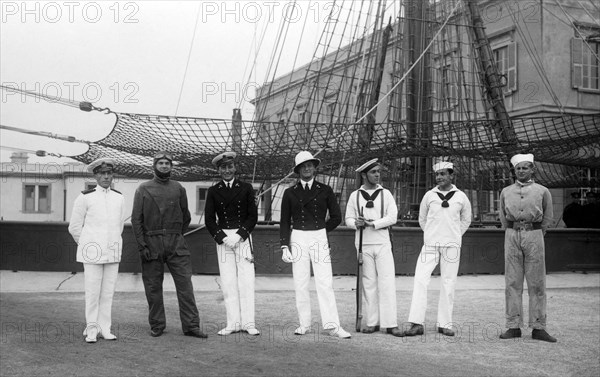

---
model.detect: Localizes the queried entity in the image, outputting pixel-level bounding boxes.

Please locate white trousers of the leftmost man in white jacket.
[83,263,119,338]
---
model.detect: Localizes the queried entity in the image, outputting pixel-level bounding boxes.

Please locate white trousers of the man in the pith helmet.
[290,229,340,329]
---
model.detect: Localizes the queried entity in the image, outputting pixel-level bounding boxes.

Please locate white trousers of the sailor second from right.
[408,245,460,328]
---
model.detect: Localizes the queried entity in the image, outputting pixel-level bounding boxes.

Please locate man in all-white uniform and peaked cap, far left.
[69,158,125,343]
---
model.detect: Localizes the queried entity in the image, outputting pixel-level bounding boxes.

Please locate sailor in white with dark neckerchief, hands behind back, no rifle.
[404,161,471,336]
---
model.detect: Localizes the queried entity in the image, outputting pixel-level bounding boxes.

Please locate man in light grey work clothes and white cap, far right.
[500,153,556,343]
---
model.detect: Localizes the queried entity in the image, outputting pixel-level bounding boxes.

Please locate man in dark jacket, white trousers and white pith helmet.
[279,151,350,338]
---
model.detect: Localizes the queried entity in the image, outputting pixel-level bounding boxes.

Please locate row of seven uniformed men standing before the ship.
[69,151,556,343]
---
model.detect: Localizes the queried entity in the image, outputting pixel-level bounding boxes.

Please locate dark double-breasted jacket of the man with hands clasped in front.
[204,178,258,245]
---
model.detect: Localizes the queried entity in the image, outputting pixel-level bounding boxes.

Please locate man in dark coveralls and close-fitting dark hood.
[131,152,206,338]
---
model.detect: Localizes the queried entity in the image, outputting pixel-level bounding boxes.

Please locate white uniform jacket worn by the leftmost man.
[69,186,126,264]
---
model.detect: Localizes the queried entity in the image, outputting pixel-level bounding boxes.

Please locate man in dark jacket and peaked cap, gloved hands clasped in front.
[204,152,259,335]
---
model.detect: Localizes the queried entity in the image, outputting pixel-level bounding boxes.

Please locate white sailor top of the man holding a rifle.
[345,185,398,247]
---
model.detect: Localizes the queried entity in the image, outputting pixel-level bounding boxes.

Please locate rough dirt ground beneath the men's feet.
[0,288,600,376]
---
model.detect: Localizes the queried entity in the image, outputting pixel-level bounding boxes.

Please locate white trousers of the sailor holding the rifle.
[362,243,398,328]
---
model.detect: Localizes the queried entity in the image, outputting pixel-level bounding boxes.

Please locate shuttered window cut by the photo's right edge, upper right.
[571,38,600,91]
